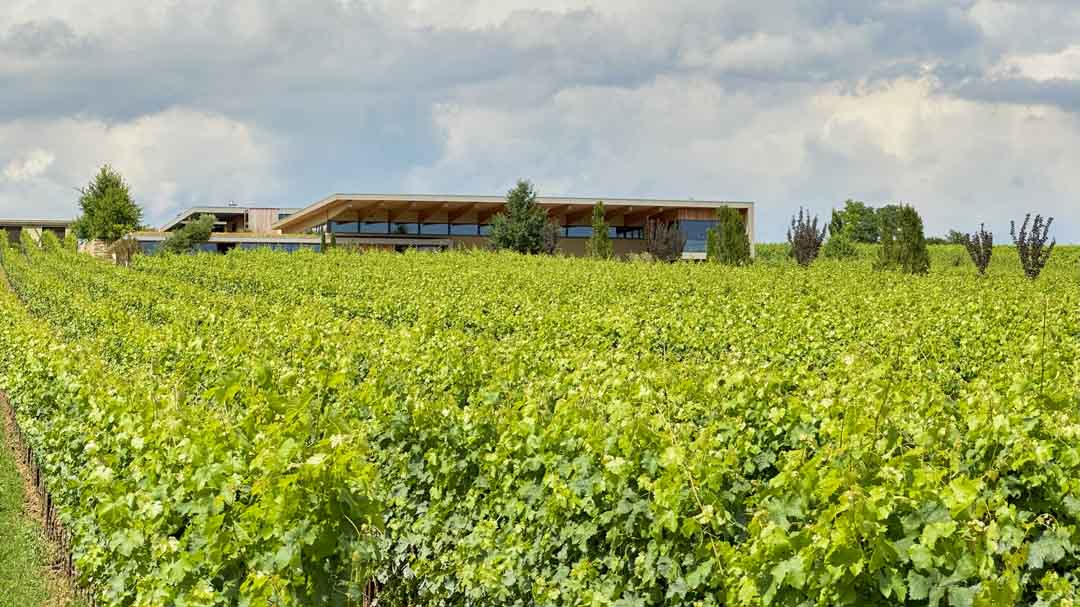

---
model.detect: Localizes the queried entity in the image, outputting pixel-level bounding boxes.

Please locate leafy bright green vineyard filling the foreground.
[0,238,1080,607]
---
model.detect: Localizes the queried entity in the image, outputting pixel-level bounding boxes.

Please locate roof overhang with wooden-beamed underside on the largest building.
[272,194,754,232]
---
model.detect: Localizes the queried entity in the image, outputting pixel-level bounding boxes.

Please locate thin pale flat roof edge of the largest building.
[272,193,754,230]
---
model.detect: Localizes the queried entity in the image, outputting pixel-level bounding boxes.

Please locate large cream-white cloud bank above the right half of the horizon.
[408,79,1080,240]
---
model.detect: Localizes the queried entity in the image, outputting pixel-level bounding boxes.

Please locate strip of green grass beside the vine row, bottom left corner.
[0,412,49,607]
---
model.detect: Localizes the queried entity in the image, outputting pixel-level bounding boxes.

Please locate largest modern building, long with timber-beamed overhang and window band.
[272,194,754,259]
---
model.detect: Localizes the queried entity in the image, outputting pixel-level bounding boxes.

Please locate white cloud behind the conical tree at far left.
[0,109,281,220]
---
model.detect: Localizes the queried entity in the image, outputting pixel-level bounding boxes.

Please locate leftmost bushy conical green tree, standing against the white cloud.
[73,164,143,242]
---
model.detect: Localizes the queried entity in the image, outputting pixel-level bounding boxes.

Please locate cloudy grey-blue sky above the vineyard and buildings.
[0,0,1080,242]
